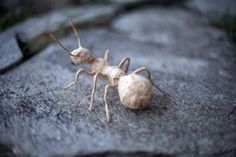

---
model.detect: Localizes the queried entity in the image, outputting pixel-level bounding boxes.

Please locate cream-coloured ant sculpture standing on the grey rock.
[50,18,165,122]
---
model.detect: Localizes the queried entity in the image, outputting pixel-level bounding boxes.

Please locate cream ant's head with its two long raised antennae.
[50,18,95,64]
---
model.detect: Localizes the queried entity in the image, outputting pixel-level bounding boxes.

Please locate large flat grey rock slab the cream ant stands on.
[0,5,236,157]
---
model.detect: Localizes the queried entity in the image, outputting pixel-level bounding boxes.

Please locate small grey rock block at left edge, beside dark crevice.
[0,36,22,73]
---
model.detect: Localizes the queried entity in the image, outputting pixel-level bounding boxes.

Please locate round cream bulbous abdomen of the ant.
[118,74,153,109]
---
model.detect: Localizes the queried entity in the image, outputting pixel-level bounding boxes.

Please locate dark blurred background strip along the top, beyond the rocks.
[0,0,236,41]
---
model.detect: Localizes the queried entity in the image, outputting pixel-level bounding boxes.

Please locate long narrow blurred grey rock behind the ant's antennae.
[1,5,116,53]
